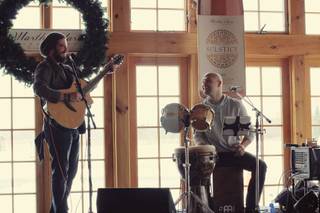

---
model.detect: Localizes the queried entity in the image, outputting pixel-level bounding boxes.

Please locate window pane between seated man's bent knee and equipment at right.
[264,156,283,184]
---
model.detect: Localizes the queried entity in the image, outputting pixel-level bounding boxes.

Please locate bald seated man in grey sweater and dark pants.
[194,72,267,212]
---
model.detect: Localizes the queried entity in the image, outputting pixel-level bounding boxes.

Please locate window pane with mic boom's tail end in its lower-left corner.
[263,97,282,125]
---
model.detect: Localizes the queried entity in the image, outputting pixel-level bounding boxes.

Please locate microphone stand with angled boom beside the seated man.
[231,88,271,211]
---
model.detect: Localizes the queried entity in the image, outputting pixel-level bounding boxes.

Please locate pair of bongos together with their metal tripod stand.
[160,103,214,213]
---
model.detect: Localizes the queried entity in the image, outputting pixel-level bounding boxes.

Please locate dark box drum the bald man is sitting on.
[212,167,244,213]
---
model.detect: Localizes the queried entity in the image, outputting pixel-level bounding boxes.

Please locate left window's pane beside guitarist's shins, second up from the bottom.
[13,163,36,193]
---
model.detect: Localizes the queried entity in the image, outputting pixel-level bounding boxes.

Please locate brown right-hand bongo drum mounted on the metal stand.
[190,104,215,131]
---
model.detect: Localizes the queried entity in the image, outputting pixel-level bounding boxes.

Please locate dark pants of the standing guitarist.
[44,121,79,213]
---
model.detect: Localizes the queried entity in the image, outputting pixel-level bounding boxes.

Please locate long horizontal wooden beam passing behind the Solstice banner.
[109,32,320,58]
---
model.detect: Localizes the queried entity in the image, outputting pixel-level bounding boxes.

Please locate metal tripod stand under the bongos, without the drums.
[175,126,214,213]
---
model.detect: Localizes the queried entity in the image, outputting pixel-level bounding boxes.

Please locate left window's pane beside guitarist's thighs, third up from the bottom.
[13,131,35,161]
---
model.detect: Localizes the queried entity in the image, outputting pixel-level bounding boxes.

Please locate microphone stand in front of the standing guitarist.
[68,56,97,213]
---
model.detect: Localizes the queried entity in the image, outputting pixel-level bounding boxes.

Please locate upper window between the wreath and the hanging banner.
[131,0,187,31]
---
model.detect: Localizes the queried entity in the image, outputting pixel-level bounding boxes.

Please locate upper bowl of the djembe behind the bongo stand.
[173,145,217,186]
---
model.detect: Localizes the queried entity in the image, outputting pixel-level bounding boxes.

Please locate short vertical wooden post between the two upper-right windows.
[288,0,305,35]
